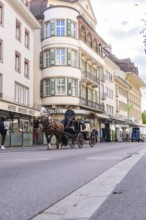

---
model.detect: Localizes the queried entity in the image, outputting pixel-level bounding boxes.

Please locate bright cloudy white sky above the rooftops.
[90,0,146,111]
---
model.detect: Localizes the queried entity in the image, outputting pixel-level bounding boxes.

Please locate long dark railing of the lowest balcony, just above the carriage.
[80,98,104,111]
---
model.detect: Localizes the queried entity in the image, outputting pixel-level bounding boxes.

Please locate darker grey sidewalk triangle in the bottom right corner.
[90,148,146,220]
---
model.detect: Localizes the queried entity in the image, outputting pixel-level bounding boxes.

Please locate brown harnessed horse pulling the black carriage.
[39,115,64,149]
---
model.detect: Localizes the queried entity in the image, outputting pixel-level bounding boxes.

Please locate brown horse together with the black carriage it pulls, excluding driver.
[36,115,97,149]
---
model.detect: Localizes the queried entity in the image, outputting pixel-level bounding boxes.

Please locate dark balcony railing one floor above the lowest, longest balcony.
[82,71,99,87]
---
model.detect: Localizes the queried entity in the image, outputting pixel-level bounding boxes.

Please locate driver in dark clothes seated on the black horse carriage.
[62,105,75,128]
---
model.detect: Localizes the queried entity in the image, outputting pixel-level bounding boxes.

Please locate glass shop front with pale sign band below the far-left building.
[0,102,39,146]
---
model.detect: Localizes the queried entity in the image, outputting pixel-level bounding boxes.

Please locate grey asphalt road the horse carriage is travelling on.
[0,143,145,220]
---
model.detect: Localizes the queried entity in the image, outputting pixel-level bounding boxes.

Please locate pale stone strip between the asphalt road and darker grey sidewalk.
[32,149,146,220]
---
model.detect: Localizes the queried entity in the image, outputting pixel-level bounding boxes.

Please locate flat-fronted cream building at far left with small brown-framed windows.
[0,0,40,130]
